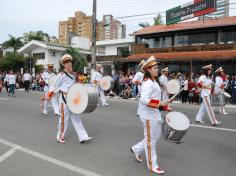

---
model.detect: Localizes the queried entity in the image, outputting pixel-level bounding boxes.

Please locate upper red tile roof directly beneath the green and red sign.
[135,16,236,35]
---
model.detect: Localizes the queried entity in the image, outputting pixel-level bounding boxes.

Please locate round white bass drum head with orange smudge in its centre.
[66,83,96,114]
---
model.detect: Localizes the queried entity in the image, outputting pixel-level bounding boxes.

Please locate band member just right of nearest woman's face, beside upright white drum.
[159,67,169,100]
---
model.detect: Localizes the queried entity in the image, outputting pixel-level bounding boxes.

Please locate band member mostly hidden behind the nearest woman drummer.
[132,60,145,116]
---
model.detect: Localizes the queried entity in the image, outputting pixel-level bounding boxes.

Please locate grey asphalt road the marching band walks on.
[0,91,236,176]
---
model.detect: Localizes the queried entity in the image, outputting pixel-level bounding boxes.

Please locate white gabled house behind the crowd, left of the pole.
[18,40,91,71]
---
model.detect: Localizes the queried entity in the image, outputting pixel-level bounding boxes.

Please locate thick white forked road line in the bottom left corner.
[0,138,103,176]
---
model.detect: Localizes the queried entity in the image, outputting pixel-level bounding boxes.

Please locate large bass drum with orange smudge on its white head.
[66,83,98,114]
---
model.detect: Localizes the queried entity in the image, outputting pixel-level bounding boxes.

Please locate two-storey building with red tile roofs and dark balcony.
[124,16,236,73]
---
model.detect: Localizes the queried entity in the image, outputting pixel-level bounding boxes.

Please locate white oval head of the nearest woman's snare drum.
[165,112,190,131]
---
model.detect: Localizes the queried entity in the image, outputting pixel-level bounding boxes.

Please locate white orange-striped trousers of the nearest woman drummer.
[132,119,162,170]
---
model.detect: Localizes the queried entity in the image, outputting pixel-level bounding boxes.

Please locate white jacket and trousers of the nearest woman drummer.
[132,79,162,170]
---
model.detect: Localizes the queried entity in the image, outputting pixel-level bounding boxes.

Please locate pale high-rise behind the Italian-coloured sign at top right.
[199,0,229,20]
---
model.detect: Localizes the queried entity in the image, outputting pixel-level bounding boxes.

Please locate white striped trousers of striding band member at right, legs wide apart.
[196,96,217,124]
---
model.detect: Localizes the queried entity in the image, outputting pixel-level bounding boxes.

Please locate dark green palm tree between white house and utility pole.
[62,48,88,72]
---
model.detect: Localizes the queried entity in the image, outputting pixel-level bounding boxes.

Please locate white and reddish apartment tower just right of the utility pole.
[98,15,126,40]
